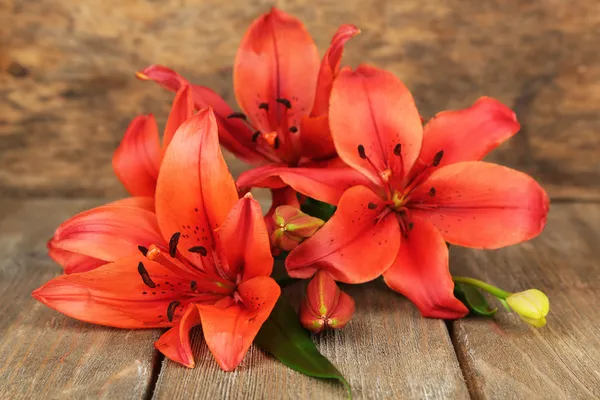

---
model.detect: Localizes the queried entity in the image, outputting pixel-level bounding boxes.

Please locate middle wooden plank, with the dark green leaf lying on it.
[154,282,468,400]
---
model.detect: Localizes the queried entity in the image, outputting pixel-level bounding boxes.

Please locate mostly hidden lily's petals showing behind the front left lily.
[48,85,194,274]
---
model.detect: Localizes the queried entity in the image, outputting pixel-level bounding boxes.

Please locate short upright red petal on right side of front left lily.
[216,193,273,281]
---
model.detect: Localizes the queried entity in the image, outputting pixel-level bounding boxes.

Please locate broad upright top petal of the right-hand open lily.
[329,65,423,184]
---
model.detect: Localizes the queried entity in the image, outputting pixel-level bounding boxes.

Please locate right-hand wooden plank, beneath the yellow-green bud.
[451,204,600,399]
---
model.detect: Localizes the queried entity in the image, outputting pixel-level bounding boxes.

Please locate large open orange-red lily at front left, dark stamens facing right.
[33,109,280,371]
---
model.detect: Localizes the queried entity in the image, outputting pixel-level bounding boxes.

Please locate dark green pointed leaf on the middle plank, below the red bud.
[254,297,351,396]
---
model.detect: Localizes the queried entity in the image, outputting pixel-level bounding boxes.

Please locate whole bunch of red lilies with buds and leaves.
[33,8,549,390]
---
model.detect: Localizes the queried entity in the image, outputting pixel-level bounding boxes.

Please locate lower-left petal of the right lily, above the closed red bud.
[285,186,400,283]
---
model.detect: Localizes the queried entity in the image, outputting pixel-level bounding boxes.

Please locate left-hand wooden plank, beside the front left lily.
[0,200,159,399]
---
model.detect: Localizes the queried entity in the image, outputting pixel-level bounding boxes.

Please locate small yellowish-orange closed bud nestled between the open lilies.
[271,206,325,251]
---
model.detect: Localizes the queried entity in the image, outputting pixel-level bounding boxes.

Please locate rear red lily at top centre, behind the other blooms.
[137,8,368,209]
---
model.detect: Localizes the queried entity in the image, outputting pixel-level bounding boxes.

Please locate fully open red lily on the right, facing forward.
[286,66,549,318]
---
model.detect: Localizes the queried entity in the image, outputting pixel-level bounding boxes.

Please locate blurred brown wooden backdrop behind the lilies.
[0,0,600,199]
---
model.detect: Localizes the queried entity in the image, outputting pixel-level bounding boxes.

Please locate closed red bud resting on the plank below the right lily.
[300,271,354,333]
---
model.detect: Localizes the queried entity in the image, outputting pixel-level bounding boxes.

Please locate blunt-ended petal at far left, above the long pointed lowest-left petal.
[48,199,164,273]
